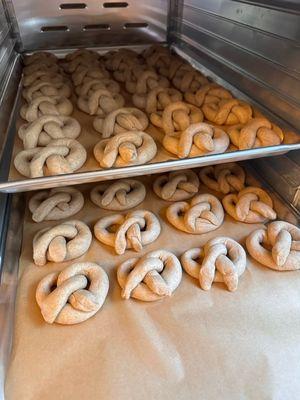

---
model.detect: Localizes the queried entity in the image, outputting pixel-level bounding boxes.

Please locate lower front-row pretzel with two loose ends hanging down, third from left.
[181,237,247,292]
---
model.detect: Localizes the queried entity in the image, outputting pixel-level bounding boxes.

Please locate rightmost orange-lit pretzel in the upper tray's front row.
[227,118,283,150]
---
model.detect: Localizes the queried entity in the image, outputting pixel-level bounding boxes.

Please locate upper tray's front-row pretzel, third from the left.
[163,122,230,158]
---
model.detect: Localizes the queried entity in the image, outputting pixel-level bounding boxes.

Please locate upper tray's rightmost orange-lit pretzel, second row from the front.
[202,99,252,125]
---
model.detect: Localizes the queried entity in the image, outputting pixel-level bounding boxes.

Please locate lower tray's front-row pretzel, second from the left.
[117,250,182,301]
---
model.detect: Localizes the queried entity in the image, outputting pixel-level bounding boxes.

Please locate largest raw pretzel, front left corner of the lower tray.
[36,262,109,325]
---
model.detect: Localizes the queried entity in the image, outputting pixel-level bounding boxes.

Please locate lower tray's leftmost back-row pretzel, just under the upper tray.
[28,187,84,222]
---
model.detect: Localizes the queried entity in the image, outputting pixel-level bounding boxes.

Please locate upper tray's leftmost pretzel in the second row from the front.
[18,115,81,150]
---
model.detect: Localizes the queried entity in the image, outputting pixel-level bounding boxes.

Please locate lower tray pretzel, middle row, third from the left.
[166,193,224,234]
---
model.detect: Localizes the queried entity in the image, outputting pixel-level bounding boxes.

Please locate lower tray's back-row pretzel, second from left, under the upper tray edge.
[90,179,146,211]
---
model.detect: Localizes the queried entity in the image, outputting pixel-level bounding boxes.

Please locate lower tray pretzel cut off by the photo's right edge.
[246,221,300,271]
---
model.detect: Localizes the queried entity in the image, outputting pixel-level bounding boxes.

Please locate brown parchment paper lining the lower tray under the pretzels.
[6,176,300,400]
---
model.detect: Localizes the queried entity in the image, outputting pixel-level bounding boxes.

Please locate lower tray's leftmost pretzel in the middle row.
[33,220,92,266]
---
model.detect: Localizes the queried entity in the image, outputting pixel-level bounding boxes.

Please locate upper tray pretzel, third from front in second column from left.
[77,89,125,116]
